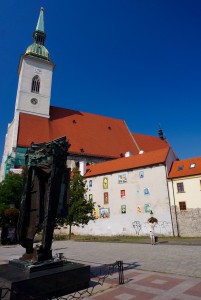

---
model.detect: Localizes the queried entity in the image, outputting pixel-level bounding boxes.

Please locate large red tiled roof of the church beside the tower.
[18,106,174,158]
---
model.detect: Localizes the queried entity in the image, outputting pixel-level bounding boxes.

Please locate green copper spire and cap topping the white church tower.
[26,7,50,61]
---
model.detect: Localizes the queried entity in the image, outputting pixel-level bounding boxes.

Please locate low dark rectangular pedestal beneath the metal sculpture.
[0,262,90,300]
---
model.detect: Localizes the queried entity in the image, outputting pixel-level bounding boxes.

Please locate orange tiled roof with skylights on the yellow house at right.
[168,157,201,179]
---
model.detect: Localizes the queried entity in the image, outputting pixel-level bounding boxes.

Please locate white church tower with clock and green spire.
[0,8,55,181]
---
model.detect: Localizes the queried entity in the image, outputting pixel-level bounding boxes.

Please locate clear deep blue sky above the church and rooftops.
[0,0,201,159]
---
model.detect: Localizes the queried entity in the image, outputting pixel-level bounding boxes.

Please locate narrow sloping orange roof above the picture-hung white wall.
[85,147,170,177]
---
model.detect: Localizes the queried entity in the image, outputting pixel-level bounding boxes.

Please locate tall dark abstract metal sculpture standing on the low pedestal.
[17,137,70,261]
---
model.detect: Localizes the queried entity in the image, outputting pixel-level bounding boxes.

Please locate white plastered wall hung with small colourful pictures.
[68,165,173,236]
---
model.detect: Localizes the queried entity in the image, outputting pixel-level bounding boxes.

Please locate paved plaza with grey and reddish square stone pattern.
[0,241,201,300]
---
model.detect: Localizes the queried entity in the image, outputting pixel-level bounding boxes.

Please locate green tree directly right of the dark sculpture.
[65,169,95,239]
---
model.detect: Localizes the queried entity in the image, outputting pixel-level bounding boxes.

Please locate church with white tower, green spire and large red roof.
[0,8,174,181]
